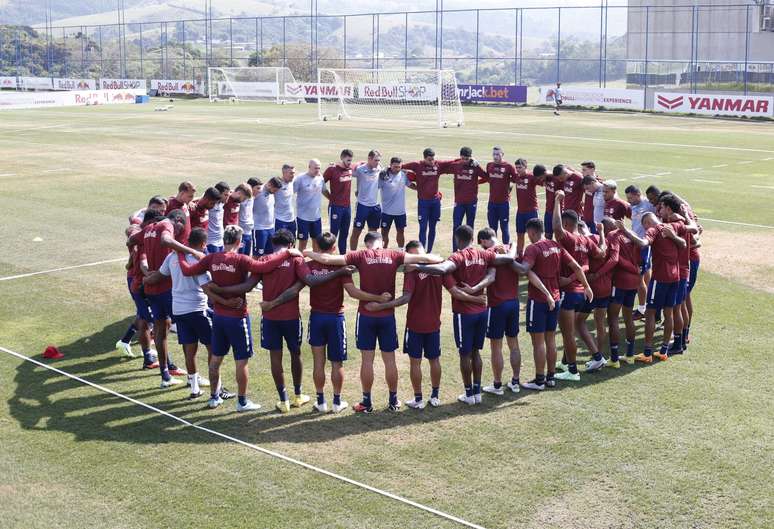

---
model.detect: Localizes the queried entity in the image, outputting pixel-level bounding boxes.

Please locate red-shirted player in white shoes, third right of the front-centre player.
[478,229,551,395]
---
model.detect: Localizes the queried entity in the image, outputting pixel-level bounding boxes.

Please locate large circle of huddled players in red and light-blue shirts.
[117,147,701,413]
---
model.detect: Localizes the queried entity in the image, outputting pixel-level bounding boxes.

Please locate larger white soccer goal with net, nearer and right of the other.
[317,68,464,127]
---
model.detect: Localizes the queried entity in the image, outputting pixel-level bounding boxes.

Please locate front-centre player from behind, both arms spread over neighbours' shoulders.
[305,232,442,413]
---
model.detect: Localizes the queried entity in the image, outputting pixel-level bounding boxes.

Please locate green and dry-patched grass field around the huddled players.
[0,102,774,529]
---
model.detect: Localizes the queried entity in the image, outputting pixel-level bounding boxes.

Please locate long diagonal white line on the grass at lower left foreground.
[0,346,492,529]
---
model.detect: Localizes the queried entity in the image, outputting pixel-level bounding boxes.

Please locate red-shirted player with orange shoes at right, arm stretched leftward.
[616,208,686,364]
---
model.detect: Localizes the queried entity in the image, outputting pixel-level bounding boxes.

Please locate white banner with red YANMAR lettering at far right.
[653,92,774,118]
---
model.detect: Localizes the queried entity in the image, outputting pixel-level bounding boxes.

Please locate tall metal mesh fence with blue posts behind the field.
[0,1,774,93]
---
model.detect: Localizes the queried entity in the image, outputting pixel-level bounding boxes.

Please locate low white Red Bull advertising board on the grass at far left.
[0,89,146,110]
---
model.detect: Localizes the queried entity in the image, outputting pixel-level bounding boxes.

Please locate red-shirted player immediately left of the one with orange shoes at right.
[602,217,642,368]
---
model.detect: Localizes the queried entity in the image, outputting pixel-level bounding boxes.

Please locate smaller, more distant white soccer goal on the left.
[207,66,303,103]
